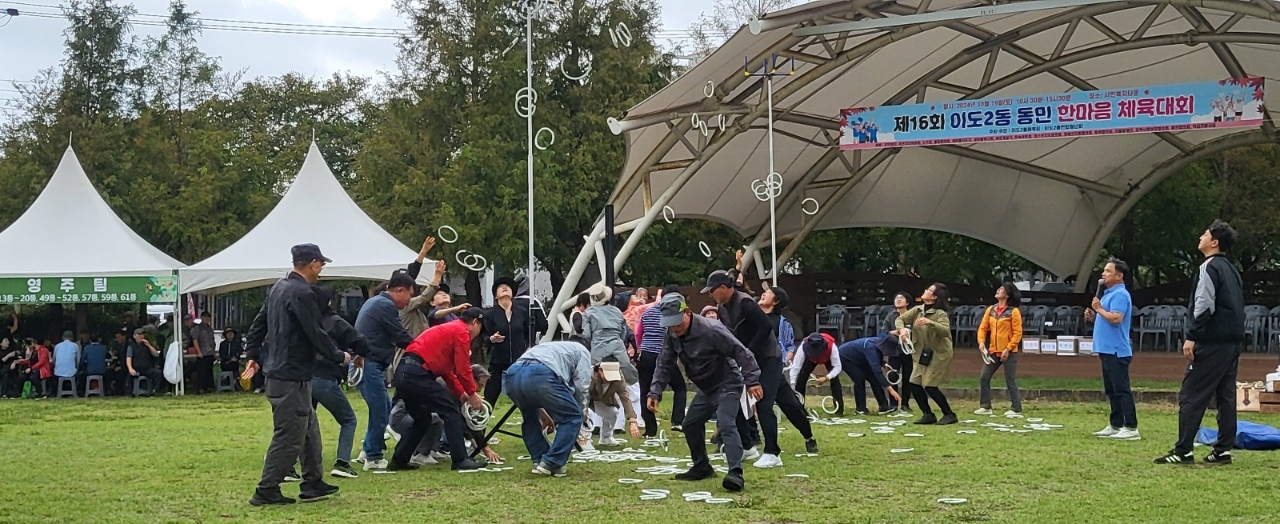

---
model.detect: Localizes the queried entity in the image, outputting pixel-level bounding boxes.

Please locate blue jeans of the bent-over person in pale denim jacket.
[502,360,582,468]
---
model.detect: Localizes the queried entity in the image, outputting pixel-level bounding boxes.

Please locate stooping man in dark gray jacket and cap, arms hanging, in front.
[645,293,764,491]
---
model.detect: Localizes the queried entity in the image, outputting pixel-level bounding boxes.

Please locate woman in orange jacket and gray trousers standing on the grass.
[974,282,1023,415]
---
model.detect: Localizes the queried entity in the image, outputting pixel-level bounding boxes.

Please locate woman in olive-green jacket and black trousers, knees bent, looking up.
[895,283,960,424]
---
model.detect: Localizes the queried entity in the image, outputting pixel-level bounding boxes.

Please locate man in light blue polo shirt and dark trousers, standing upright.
[1084,259,1142,441]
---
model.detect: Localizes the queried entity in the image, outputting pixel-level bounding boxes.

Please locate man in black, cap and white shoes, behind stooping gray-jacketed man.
[703,270,818,468]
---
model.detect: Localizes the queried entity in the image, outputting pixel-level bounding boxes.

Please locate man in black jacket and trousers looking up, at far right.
[1156,220,1244,464]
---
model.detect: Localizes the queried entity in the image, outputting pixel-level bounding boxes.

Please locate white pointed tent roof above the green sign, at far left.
[0,146,183,278]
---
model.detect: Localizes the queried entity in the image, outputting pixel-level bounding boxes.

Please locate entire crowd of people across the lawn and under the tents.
[10,222,1244,505]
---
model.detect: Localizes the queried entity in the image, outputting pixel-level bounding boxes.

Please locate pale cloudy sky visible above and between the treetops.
[0,0,712,93]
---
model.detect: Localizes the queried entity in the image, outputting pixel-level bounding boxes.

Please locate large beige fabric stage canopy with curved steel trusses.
[545,0,1280,338]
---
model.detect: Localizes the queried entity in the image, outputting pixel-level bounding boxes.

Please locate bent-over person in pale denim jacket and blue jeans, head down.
[502,337,591,477]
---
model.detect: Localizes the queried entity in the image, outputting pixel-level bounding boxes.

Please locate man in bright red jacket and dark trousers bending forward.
[389,309,484,470]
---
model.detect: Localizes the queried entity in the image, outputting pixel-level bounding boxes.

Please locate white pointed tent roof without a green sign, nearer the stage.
[180,142,434,293]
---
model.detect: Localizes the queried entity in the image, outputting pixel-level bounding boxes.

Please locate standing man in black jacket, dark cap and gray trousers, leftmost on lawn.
[243,243,347,506]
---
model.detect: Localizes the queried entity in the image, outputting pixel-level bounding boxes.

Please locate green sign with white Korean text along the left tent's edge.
[0,274,178,304]
